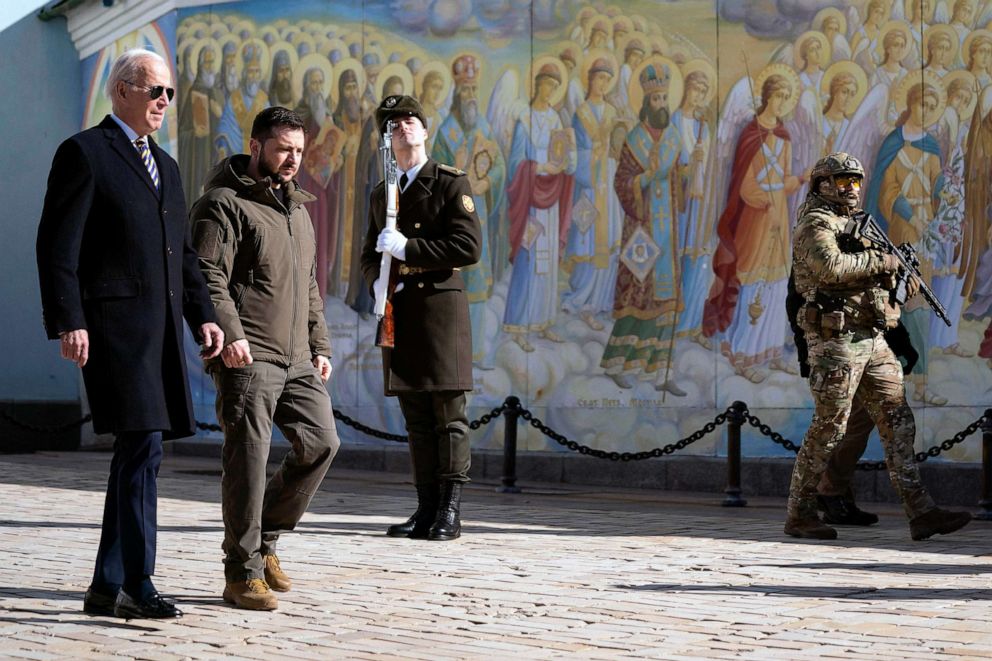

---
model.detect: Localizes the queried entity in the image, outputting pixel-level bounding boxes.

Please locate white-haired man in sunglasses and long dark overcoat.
[37,50,223,618]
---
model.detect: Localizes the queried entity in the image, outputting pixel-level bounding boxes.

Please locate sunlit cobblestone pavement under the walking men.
[0,453,992,661]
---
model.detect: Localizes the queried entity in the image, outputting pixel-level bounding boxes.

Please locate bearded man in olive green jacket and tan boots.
[190,107,339,610]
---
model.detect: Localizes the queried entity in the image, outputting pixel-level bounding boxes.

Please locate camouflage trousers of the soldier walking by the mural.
[788,330,936,519]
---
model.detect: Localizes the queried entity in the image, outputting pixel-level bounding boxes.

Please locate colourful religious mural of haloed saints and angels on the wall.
[83,0,992,461]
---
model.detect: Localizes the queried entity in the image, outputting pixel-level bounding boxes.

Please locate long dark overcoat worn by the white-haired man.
[37,116,215,438]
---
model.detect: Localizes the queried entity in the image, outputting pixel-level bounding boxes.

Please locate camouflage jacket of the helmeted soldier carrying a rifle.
[792,193,899,333]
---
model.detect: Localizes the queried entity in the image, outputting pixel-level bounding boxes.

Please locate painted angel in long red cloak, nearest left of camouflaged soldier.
[703,64,802,383]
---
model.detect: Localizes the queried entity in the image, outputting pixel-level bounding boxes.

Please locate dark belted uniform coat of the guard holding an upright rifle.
[362,160,482,395]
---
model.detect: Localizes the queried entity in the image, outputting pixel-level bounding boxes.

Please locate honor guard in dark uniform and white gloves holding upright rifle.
[361,95,482,540]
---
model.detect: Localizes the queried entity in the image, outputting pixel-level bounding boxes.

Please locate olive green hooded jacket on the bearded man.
[190,155,331,366]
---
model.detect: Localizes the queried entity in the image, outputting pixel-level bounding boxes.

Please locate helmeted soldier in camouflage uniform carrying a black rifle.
[785,153,971,539]
